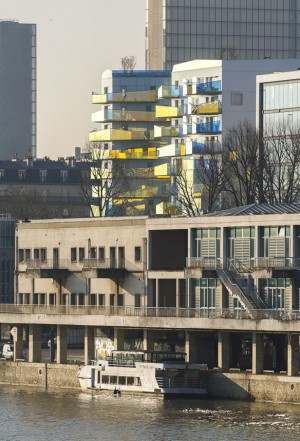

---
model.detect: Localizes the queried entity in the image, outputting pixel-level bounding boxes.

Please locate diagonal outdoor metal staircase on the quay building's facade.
[216,260,266,310]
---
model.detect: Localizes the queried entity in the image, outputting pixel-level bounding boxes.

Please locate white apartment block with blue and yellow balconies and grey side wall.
[154,59,299,214]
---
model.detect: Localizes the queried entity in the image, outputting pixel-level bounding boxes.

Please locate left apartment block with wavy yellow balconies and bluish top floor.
[89,70,171,215]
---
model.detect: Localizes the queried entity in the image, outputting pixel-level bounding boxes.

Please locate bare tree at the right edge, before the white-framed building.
[261,122,300,204]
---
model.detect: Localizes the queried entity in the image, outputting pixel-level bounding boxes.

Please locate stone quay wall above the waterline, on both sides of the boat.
[0,362,300,404]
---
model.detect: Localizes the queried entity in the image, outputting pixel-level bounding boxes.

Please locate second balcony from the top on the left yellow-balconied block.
[92,109,157,123]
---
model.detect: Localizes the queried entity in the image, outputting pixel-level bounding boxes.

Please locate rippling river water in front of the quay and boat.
[0,387,300,441]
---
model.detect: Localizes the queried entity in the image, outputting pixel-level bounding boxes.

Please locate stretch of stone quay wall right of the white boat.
[207,372,300,404]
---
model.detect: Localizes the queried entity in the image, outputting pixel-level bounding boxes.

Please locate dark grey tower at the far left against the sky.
[0,21,36,160]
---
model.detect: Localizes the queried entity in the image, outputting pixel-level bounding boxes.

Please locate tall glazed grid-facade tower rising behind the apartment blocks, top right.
[146,0,300,69]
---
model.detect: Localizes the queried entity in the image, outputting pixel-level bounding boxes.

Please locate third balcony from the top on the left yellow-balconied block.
[89,128,154,142]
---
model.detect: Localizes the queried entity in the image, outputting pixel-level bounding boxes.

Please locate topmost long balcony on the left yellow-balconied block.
[92,90,156,104]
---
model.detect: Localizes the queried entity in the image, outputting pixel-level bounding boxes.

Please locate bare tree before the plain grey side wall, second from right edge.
[222,121,260,207]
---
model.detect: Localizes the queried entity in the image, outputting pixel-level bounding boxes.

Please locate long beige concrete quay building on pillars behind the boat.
[1,203,300,376]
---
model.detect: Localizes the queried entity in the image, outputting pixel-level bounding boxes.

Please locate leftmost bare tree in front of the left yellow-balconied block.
[81,142,129,217]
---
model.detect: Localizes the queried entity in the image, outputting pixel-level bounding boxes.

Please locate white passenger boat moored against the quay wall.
[78,351,207,396]
